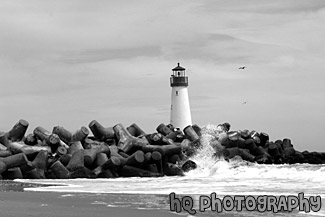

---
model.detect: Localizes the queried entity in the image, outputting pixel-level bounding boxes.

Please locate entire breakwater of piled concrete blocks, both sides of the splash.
[0,120,325,179]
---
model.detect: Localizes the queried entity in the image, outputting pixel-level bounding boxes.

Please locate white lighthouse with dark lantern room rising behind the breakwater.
[170,63,192,130]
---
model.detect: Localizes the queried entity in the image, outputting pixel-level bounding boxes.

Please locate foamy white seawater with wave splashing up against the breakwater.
[16,125,325,216]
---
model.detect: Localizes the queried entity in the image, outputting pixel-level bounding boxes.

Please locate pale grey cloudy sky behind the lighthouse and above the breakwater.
[0,0,325,152]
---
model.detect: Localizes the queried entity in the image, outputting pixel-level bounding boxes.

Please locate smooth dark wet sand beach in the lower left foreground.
[0,181,179,217]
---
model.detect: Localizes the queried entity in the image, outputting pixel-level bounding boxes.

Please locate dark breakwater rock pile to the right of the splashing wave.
[208,125,325,164]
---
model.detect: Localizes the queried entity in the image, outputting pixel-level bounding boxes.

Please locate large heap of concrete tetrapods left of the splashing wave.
[0,119,201,179]
